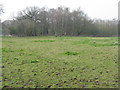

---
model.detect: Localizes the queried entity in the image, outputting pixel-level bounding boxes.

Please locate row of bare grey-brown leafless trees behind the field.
[2,7,118,36]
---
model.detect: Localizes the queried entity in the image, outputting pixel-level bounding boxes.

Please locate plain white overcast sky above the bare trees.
[0,0,119,21]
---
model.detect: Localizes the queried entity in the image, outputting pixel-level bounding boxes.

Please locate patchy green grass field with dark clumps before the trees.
[1,36,118,88]
